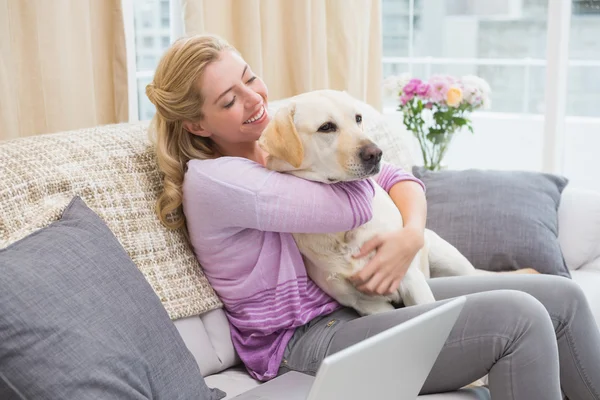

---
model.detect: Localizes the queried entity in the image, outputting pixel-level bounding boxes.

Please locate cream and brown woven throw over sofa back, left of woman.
[0,123,222,319]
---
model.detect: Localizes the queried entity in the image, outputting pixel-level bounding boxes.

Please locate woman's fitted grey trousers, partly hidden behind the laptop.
[279,275,600,400]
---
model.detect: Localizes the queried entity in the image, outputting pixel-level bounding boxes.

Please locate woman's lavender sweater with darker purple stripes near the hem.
[183,157,422,381]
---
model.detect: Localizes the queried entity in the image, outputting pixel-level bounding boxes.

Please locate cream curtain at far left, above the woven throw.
[0,0,128,140]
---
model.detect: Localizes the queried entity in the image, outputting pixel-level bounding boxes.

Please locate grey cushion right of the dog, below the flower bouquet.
[413,167,571,277]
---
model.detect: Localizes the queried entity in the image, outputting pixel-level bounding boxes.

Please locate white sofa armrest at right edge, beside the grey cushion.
[558,186,600,270]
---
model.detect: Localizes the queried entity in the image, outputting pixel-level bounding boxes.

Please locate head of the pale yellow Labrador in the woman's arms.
[259,90,382,183]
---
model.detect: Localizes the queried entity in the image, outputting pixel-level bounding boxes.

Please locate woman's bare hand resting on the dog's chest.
[349,226,424,295]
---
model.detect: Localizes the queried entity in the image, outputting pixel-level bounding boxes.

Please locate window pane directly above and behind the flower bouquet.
[382,0,548,114]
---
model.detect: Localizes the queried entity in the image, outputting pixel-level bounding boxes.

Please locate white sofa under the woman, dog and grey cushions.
[175,101,600,400]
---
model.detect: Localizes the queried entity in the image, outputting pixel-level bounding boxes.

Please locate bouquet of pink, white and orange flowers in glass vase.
[384,75,491,171]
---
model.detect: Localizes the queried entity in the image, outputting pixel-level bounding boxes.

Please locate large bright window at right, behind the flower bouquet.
[382,0,600,190]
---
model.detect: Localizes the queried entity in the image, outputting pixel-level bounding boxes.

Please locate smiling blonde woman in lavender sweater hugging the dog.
[146,35,600,400]
